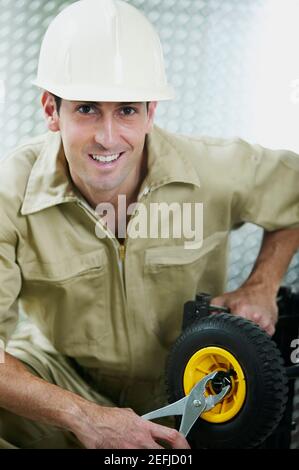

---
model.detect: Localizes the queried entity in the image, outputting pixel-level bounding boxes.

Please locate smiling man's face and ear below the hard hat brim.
[43,92,156,194]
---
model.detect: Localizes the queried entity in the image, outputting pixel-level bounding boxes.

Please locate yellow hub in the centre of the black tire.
[184,346,246,423]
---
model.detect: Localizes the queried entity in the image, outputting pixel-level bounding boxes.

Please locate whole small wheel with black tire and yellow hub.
[166,313,288,449]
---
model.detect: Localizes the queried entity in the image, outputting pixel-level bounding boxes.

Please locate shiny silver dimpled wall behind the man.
[0,0,299,447]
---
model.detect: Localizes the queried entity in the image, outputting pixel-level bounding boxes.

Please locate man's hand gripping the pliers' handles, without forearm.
[73,402,190,449]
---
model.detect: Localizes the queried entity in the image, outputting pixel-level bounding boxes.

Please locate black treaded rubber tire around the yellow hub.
[166,313,288,449]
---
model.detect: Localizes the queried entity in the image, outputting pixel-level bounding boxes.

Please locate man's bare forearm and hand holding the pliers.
[0,353,189,449]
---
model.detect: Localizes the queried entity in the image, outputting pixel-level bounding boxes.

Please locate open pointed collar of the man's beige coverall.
[21,126,200,215]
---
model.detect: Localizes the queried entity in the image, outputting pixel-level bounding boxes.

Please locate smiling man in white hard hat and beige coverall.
[0,0,299,448]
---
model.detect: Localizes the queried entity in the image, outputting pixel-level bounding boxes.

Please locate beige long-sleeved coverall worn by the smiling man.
[0,127,299,447]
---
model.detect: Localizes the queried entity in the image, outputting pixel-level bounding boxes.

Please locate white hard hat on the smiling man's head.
[33,0,174,102]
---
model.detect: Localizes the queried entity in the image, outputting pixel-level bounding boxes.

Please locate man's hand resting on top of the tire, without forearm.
[211,285,278,336]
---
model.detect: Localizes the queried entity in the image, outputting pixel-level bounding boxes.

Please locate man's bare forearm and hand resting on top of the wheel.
[212,229,299,335]
